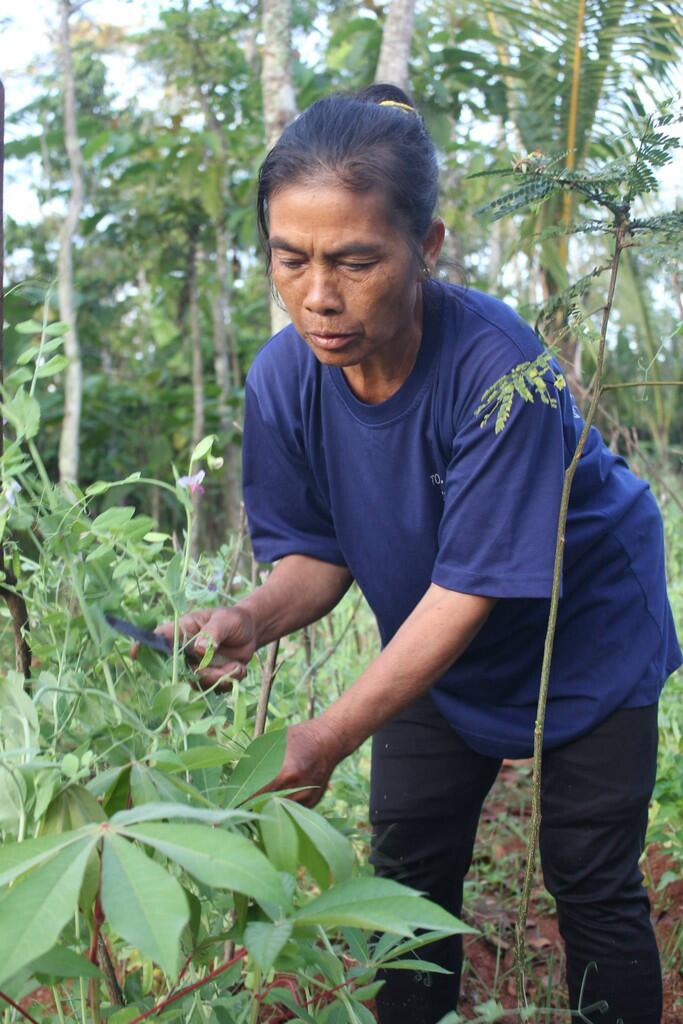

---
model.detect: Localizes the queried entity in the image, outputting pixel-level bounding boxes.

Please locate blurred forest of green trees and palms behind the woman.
[0,0,683,1020]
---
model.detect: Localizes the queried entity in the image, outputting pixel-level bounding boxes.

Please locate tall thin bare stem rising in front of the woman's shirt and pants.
[515,221,627,1006]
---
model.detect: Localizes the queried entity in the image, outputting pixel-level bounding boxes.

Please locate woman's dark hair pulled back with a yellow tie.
[257,83,438,267]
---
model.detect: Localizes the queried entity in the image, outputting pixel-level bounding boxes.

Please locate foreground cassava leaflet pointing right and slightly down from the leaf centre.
[127,824,290,907]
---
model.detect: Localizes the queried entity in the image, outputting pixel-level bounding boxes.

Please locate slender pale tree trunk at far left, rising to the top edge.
[57,0,83,482]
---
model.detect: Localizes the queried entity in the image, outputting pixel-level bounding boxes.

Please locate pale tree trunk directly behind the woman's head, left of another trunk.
[261,0,297,334]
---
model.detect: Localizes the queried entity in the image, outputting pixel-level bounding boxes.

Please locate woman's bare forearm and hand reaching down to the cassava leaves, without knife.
[266,584,496,807]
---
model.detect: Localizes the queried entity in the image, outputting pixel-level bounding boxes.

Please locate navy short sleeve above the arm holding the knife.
[243,385,345,565]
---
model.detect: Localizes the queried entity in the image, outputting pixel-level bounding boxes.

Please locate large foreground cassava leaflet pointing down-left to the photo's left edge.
[0,835,98,985]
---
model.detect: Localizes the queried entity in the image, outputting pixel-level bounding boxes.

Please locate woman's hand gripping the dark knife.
[155,604,257,692]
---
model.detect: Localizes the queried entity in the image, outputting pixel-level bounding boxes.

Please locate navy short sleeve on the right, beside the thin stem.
[432,377,565,598]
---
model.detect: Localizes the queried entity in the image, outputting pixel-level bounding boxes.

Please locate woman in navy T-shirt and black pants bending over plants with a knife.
[160,86,681,1024]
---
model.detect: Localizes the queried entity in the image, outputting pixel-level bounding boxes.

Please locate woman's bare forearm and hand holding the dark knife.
[157,555,352,688]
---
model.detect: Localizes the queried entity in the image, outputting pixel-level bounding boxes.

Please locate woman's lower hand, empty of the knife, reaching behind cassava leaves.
[260,718,345,807]
